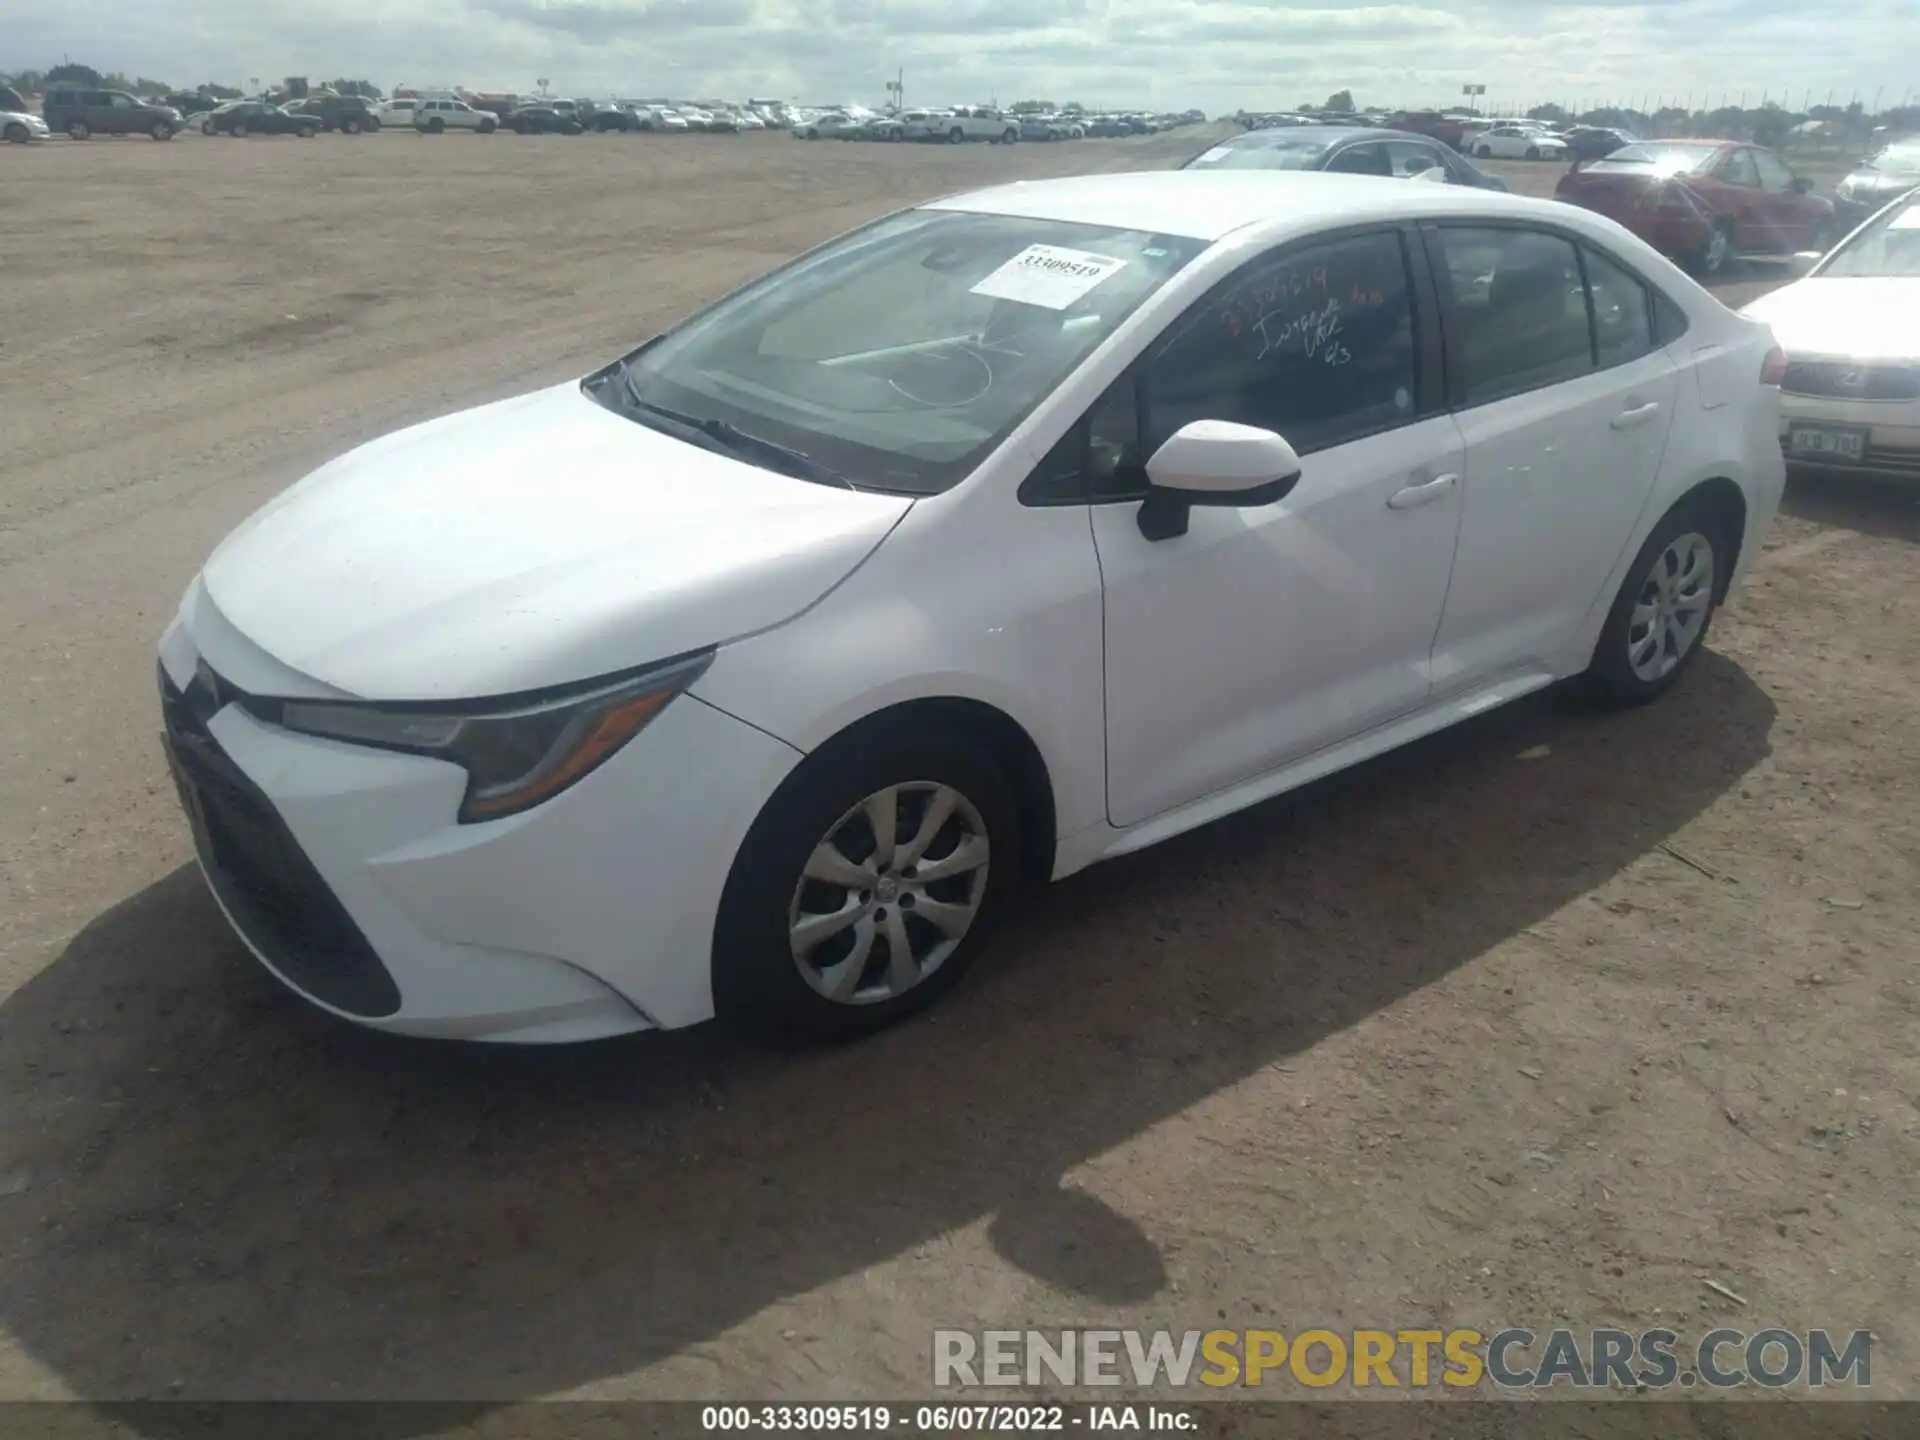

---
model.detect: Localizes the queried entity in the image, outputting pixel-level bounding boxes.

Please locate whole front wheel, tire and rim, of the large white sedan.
[712,726,1020,1043]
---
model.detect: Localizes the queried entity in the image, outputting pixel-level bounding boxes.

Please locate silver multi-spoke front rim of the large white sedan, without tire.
[787,781,991,1006]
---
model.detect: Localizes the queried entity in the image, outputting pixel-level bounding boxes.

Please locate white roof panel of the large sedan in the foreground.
[925,171,1543,242]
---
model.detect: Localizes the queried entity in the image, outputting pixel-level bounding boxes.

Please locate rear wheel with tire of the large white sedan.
[1582,507,1732,705]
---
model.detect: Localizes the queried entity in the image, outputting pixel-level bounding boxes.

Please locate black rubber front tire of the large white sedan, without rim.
[712,724,1020,1044]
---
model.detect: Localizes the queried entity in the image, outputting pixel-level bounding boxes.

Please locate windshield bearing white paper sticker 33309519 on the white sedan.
[588,209,1206,493]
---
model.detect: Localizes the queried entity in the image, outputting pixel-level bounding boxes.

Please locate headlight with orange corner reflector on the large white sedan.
[273,651,712,824]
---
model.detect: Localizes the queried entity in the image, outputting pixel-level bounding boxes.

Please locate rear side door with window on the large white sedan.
[1423,221,1680,691]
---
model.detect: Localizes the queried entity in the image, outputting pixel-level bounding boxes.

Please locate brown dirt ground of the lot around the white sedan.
[0,132,1920,1405]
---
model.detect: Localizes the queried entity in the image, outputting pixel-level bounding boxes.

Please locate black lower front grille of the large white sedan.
[159,666,399,1020]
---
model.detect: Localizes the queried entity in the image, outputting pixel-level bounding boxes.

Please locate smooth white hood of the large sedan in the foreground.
[202,384,912,701]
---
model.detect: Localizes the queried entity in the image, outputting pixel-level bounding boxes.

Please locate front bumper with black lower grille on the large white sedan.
[159,620,801,1043]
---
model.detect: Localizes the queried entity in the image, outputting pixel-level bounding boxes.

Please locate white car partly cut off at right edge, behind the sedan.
[1745,194,1920,480]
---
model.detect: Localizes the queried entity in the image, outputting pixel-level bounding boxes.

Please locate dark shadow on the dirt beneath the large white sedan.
[0,653,1774,1432]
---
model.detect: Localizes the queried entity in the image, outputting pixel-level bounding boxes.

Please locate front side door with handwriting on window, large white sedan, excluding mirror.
[1089,228,1461,826]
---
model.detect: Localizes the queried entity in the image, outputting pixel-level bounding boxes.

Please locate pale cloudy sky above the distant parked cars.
[0,0,1920,113]
